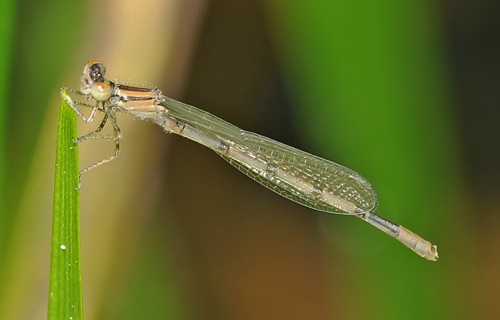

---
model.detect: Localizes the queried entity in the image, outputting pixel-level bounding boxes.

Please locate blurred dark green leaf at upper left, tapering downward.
[7,0,86,223]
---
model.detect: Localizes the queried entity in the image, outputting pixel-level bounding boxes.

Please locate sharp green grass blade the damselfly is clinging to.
[48,94,83,320]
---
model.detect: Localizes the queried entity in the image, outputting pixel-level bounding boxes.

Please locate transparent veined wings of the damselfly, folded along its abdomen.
[161,97,378,214]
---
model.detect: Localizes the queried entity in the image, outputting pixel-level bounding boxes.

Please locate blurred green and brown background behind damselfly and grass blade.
[0,0,500,319]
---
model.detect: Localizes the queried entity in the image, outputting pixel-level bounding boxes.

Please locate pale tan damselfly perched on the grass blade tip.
[61,61,438,261]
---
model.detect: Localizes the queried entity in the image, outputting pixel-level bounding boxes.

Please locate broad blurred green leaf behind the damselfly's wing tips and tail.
[272,0,459,319]
